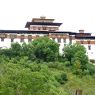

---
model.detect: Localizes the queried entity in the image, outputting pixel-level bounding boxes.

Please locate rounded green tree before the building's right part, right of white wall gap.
[64,44,88,70]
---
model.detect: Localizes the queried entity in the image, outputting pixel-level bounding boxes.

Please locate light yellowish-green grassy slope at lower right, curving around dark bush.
[50,62,95,95]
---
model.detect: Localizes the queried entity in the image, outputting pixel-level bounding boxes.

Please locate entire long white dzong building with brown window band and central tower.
[0,17,95,59]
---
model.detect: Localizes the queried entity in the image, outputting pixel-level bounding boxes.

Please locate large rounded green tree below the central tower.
[31,37,59,61]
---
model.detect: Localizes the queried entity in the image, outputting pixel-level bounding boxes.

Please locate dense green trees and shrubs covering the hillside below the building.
[0,37,95,95]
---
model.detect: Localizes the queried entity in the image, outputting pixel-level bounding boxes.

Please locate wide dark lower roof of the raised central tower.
[25,22,62,28]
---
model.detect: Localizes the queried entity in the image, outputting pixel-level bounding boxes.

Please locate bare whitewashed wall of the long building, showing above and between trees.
[0,34,95,59]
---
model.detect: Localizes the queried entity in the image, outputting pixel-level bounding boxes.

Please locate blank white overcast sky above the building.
[0,0,95,33]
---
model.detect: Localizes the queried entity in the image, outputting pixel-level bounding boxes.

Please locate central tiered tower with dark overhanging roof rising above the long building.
[25,16,62,31]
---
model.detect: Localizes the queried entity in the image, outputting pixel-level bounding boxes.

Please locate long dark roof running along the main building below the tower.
[0,30,94,39]
